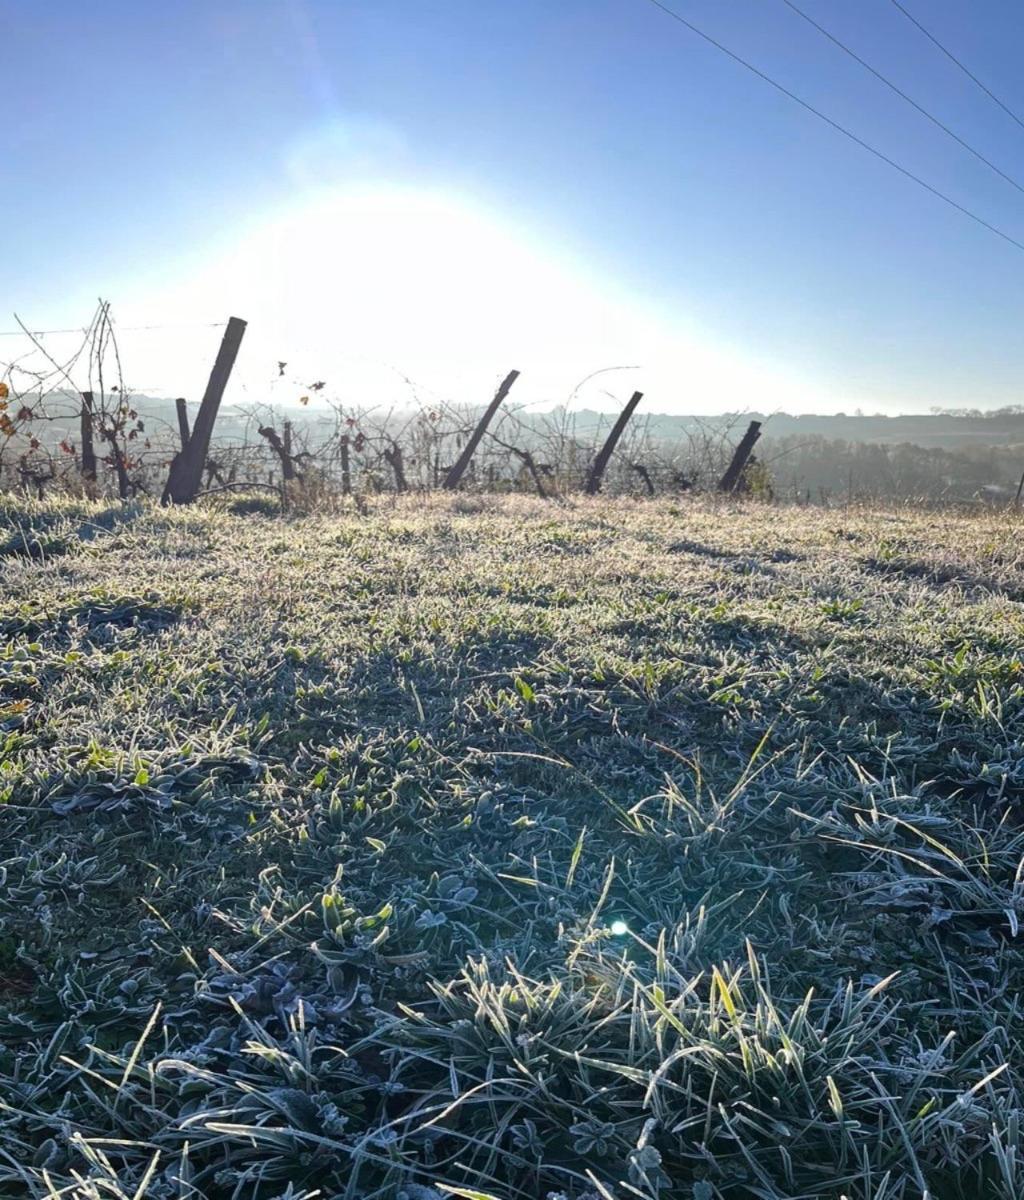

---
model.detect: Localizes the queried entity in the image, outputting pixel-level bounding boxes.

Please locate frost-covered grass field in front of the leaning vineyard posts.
[0,499,1024,1200]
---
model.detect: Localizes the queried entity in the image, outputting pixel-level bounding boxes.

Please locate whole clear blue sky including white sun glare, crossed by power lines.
[6,0,1024,412]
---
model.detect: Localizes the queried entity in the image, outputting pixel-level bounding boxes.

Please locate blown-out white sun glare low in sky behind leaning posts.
[103,187,821,412]
